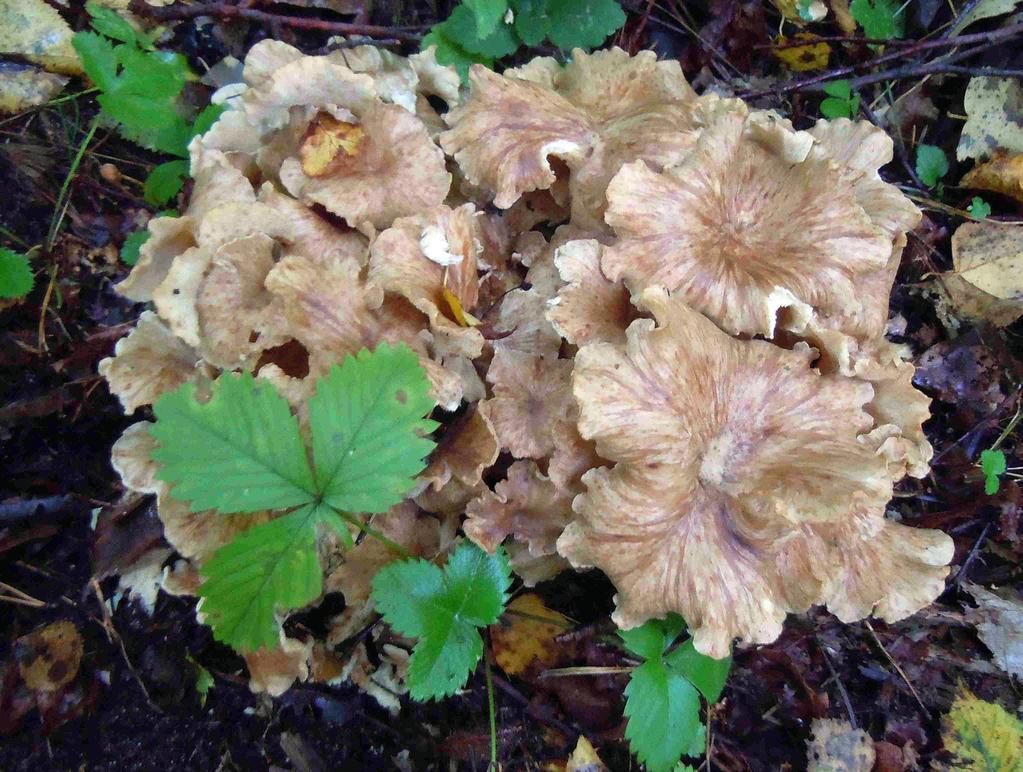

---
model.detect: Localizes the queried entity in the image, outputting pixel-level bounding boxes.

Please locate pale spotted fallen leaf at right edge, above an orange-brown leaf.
[955,78,1023,161]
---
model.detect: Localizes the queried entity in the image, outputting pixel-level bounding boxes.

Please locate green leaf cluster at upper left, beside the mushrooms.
[72,3,222,206]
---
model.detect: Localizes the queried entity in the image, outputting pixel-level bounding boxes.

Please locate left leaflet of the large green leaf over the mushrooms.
[149,373,316,514]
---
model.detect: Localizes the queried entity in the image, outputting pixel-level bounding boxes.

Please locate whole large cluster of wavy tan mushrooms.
[101,41,952,705]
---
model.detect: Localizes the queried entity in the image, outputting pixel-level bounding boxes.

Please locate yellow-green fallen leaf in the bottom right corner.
[941,687,1023,772]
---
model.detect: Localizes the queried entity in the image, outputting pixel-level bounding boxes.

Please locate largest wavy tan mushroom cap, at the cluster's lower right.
[558,288,951,657]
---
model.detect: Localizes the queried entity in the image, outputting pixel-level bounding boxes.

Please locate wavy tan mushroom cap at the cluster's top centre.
[441,48,697,225]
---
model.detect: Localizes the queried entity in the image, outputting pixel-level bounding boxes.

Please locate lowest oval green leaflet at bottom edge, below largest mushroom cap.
[625,660,701,772]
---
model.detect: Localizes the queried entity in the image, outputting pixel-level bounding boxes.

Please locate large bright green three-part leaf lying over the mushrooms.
[149,345,437,651]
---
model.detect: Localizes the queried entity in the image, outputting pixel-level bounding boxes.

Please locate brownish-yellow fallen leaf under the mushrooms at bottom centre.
[490,593,569,676]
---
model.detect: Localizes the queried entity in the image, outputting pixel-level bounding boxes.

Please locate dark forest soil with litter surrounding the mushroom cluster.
[0,3,1023,772]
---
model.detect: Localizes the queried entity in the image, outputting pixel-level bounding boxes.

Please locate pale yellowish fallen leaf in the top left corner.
[0,0,82,75]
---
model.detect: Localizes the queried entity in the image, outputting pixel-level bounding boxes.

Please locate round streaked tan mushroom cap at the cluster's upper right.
[602,111,892,337]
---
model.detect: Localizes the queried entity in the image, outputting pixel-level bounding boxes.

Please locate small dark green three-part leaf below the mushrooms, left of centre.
[372,542,512,700]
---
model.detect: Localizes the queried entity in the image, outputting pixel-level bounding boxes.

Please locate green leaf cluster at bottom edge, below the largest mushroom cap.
[619,614,731,772]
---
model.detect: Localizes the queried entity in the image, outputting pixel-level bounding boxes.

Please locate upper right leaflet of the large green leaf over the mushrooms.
[309,344,437,512]
